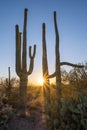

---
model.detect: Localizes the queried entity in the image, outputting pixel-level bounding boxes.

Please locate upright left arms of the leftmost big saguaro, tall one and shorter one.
[15,25,21,77]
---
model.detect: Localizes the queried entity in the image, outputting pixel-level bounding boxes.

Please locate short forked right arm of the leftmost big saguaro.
[27,45,36,75]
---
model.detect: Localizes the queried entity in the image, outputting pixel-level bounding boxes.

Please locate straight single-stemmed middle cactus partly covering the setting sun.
[42,23,50,102]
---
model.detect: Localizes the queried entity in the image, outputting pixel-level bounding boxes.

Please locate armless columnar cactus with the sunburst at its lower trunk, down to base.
[42,23,50,114]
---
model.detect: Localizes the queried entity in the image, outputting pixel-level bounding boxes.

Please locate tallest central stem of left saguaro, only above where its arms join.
[22,9,28,72]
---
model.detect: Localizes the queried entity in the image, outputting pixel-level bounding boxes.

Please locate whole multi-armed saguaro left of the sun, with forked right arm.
[16,9,36,112]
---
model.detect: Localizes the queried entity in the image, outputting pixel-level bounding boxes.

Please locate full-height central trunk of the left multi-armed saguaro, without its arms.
[20,9,28,111]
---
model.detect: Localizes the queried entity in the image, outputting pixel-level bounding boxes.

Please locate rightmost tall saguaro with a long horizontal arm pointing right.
[49,11,84,100]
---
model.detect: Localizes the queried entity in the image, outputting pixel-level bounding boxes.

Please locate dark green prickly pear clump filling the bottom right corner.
[47,93,87,130]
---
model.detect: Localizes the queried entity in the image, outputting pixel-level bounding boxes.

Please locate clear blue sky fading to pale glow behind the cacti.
[0,0,87,82]
